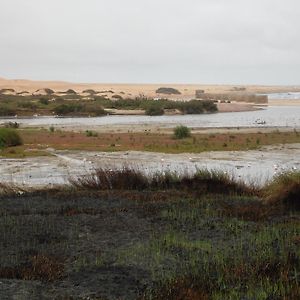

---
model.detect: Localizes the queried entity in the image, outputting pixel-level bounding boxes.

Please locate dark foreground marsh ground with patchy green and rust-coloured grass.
[0,168,300,300]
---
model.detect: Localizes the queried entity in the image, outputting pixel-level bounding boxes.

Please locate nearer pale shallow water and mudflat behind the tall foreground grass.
[0,143,300,187]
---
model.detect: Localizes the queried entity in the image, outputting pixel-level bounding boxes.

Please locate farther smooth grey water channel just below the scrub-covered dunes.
[0,106,300,128]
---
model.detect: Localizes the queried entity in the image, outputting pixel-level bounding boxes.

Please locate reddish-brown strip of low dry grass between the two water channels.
[1,129,300,157]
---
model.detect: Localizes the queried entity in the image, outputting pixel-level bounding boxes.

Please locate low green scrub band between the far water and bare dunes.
[0,91,218,117]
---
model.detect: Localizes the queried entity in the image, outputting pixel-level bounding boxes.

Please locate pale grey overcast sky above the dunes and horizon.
[0,0,300,85]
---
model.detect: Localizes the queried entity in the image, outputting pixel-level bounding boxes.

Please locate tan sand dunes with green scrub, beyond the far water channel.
[0,79,274,117]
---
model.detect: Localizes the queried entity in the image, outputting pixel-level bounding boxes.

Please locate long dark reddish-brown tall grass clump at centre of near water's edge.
[70,167,254,194]
